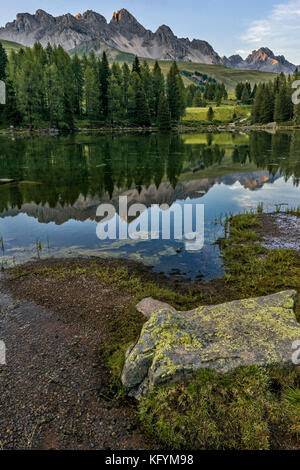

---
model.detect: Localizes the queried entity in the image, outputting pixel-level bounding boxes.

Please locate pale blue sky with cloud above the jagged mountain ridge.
[0,0,300,65]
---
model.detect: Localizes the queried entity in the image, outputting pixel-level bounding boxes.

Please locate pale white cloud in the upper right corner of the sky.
[241,0,300,64]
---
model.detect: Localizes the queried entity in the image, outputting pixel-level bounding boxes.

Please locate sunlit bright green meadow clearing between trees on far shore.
[183,105,251,123]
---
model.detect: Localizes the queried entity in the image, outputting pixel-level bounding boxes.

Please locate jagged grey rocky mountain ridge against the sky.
[0,9,296,73]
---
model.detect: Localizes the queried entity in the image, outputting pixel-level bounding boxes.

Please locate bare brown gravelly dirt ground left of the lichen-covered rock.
[0,260,158,450]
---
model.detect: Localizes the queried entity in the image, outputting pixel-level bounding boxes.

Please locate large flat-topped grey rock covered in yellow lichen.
[122,291,300,399]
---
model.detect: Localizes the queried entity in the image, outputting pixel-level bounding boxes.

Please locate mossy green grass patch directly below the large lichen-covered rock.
[139,367,300,450]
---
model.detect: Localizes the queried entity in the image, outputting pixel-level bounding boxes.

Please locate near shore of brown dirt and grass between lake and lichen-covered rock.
[0,213,300,450]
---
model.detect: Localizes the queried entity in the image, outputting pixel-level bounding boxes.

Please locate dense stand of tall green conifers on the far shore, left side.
[0,43,186,130]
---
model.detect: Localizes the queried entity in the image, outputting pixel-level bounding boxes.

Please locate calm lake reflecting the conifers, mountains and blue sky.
[0,132,300,280]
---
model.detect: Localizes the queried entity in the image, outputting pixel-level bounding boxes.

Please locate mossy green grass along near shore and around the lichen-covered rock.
[7,208,300,450]
